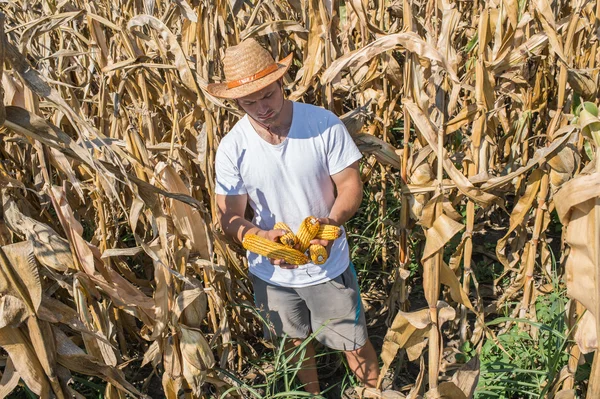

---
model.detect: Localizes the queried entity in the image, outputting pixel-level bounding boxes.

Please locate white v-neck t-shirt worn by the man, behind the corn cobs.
[215,102,362,287]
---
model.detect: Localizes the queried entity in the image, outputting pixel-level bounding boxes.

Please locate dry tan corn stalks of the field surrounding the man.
[0,0,600,399]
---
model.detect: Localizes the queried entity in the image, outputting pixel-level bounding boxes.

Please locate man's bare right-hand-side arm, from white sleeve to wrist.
[329,161,362,226]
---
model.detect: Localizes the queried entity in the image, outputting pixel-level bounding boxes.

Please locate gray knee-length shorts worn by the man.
[252,264,367,351]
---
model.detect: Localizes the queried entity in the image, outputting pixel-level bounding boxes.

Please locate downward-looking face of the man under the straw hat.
[238,81,283,125]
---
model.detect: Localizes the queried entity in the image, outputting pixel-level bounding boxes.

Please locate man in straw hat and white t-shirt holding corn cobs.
[208,39,379,394]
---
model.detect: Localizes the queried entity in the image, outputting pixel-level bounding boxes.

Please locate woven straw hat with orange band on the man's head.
[207,39,293,98]
